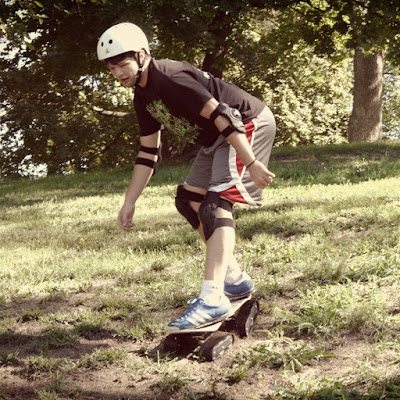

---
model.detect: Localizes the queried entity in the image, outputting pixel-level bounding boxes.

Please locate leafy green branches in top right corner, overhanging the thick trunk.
[281,0,400,62]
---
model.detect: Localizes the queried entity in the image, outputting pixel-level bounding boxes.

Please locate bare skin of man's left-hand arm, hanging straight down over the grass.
[118,131,161,229]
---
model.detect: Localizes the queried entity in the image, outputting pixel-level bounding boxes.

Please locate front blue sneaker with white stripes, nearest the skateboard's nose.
[168,296,232,332]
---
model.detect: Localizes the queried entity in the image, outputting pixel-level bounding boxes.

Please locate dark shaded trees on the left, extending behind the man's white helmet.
[0,0,272,173]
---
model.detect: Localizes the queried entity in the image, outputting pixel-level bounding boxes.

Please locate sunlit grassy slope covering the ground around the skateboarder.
[0,143,400,400]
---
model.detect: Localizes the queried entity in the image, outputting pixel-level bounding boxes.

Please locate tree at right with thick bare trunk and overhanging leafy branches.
[274,0,400,141]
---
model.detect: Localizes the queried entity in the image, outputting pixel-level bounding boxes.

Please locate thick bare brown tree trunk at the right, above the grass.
[347,49,383,142]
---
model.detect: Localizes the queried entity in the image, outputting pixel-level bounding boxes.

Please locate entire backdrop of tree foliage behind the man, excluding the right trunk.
[0,0,400,175]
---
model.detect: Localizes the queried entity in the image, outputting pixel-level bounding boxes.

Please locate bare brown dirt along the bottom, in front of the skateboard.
[0,297,390,400]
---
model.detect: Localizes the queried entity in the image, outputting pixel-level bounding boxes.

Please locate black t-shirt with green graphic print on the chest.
[134,59,265,147]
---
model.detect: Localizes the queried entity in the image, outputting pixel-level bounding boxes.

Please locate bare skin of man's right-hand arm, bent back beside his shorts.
[200,98,275,189]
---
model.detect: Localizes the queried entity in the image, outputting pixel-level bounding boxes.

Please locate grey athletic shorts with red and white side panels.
[185,107,276,206]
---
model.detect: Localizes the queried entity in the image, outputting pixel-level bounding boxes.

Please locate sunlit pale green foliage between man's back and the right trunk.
[225,13,352,145]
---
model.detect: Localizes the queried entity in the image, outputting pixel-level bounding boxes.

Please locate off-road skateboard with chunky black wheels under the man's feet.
[163,296,260,361]
